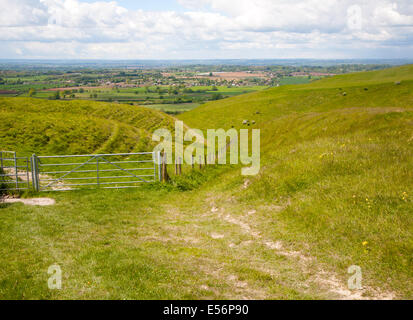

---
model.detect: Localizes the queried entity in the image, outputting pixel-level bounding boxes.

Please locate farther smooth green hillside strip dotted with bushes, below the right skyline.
[179,73,413,129]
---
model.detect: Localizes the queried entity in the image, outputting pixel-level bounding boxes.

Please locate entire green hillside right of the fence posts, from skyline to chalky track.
[180,66,413,296]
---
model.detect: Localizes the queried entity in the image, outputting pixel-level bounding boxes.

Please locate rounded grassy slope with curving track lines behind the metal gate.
[0,98,173,154]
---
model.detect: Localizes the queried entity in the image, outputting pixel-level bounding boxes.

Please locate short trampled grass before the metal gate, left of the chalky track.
[0,185,312,299]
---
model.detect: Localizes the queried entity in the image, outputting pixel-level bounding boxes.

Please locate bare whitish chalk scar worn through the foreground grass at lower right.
[211,205,395,300]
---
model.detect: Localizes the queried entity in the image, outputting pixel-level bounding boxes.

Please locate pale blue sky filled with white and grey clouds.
[0,0,413,60]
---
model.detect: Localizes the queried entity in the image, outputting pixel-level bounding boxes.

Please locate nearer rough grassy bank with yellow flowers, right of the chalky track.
[239,108,413,296]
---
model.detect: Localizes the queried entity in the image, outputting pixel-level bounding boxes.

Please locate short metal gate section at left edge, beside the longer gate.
[0,151,31,191]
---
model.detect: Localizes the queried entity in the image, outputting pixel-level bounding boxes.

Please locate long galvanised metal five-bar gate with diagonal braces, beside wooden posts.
[31,152,161,191]
